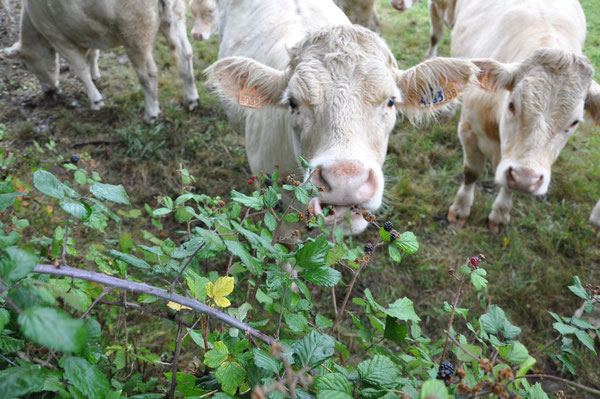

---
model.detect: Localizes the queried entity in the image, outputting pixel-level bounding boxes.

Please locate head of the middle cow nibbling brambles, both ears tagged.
[207,25,476,233]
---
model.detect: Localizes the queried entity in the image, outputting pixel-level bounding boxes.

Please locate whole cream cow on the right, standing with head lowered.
[448,0,600,232]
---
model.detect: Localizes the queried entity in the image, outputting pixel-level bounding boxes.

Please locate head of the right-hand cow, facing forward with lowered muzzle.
[473,49,600,195]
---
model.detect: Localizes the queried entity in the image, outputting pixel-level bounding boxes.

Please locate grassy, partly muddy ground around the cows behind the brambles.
[0,0,600,394]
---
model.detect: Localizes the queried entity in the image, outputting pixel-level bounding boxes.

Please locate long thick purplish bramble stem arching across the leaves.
[33,264,276,345]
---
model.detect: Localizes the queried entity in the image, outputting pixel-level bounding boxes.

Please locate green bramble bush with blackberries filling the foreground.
[0,158,600,399]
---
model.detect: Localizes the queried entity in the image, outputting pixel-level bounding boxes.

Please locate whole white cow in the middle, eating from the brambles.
[207,0,475,233]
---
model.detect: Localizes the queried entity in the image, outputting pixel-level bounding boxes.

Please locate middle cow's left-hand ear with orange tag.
[205,57,285,108]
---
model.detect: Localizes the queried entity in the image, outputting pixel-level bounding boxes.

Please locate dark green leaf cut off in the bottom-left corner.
[0,365,58,398]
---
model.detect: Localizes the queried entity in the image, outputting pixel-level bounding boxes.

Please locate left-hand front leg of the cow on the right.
[448,121,485,227]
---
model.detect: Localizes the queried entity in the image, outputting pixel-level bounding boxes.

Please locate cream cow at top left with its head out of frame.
[0,0,198,123]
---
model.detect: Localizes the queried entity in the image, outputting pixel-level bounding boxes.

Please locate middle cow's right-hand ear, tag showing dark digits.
[396,57,478,117]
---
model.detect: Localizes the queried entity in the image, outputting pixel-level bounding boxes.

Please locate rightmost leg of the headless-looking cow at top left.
[160,0,198,111]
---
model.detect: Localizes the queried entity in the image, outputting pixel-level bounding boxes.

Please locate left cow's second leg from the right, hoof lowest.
[125,46,160,123]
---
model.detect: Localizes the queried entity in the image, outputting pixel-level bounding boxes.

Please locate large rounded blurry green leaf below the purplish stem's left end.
[17,307,87,352]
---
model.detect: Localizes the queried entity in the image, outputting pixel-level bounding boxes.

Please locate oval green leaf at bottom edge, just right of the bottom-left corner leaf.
[64,357,110,399]
